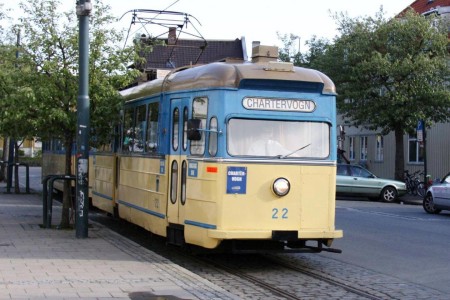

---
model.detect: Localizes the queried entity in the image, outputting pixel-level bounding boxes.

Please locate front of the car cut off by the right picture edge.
[423,173,450,214]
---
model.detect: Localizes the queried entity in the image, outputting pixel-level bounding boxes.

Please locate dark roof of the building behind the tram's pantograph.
[142,39,244,70]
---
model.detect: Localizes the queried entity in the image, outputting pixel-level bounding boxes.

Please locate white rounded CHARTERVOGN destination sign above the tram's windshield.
[242,97,316,112]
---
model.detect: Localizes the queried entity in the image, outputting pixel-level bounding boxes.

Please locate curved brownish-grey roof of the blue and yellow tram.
[120,62,336,100]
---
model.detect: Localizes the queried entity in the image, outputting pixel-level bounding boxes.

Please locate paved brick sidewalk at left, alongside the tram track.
[0,183,238,300]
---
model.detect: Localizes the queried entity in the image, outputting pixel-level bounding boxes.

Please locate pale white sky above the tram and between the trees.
[0,0,414,56]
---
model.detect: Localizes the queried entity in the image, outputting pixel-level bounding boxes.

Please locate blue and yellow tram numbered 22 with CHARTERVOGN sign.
[90,48,343,252]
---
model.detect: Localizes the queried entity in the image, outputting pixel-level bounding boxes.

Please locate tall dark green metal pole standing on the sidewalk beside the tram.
[75,0,92,238]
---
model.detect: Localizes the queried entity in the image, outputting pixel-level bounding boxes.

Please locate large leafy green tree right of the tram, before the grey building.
[310,10,450,179]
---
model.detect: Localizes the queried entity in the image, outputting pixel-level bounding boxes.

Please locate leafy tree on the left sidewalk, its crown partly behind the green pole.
[1,0,137,228]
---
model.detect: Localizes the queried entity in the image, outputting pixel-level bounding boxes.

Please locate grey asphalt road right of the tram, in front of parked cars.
[320,200,450,292]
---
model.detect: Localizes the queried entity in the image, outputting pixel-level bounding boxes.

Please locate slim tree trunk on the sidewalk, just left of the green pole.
[60,136,73,228]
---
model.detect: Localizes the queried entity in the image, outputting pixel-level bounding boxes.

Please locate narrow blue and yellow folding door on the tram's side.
[167,98,189,224]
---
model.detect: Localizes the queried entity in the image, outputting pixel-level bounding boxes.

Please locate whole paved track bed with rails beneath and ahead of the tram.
[90,211,445,300]
